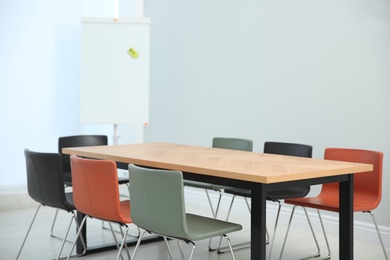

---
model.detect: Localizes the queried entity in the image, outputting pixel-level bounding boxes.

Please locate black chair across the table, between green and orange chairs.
[218,142,313,257]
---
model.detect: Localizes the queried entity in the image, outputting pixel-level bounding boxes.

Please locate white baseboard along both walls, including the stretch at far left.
[0,186,390,245]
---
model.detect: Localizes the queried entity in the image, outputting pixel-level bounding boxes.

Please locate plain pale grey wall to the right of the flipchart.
[145,0,390,226]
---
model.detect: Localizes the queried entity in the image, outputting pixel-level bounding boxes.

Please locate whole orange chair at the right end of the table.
[280,148,388,259]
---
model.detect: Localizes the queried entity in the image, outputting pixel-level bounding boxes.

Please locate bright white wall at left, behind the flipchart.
[0,0,143,189]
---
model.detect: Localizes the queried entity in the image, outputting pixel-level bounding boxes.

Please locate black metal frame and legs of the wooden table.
[77,164,354,260]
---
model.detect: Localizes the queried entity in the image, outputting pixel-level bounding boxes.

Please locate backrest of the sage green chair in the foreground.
[129,164,188,238]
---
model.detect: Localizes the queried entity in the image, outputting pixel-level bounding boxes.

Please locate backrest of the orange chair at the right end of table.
[321,148,383,211]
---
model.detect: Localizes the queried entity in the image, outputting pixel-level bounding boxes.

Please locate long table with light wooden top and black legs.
[63,143,373,260]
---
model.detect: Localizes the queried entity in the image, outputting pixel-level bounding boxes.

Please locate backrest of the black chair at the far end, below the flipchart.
[58,135,108,184]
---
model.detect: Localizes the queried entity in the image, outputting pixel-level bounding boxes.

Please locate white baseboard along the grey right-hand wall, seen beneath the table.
[185,187,390,245]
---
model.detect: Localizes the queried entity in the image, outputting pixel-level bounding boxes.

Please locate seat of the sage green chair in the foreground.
[186,214,242,241]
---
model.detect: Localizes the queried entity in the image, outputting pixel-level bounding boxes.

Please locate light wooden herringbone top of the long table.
[63,143,373,184]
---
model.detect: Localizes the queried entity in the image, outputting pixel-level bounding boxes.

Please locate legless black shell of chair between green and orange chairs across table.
[263,142,313,199]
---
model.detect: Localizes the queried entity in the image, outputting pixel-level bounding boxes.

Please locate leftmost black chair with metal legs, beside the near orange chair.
[16,149,85,259]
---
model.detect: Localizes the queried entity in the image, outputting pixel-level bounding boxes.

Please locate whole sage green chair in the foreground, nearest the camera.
[129,164,242,260]
